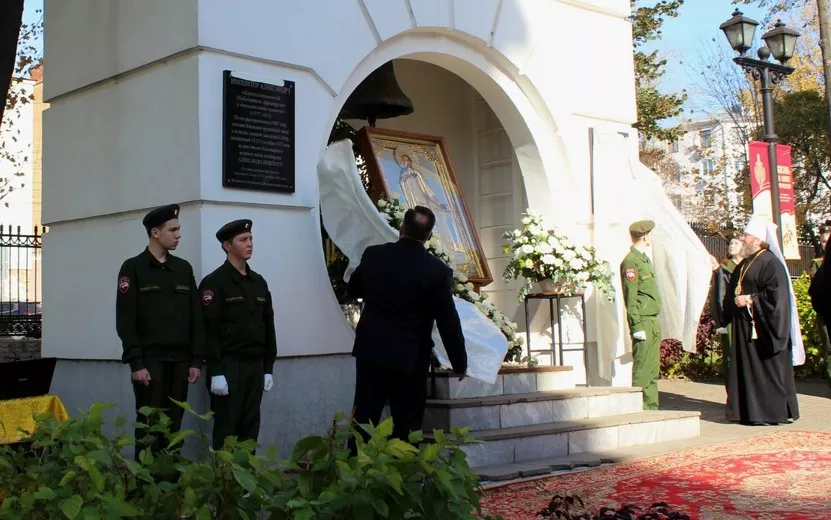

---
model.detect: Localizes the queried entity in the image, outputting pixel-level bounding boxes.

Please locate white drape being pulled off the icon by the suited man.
[317,140,508,383]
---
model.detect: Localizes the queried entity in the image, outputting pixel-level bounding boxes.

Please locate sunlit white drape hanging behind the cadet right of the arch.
[592,132,712,379]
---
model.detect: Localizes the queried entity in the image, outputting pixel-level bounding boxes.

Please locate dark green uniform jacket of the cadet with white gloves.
[199,260,277,376]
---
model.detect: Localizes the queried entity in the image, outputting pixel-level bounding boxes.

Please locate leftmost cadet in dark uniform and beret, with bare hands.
[115,204,205,459]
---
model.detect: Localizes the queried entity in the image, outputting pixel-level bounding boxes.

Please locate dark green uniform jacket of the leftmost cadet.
[115,249,205,372]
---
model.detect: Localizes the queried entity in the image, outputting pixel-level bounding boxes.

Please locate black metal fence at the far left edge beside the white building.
[0,225,46,338]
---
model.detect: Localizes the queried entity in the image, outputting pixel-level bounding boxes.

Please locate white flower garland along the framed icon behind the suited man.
[377,193,524,361]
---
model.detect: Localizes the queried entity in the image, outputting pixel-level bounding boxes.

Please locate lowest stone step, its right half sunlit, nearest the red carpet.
[442,411,700,468]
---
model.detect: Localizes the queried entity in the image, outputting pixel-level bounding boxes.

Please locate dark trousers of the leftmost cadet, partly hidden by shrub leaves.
[133,359,190,460]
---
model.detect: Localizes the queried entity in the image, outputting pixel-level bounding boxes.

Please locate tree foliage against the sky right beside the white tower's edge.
[630,0,687,141]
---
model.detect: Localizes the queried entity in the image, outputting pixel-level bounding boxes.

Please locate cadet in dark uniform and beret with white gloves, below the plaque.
[199,220,277,449]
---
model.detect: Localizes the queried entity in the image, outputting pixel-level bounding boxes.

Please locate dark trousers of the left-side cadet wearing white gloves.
[208,356,265,450]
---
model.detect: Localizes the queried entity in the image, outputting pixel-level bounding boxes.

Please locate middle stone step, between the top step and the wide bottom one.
[423,387,643,431]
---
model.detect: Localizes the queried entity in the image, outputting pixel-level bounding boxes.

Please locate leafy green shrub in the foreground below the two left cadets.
[0,403,494,520]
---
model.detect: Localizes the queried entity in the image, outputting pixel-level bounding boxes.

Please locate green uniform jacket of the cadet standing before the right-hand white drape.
[620,247,661,334]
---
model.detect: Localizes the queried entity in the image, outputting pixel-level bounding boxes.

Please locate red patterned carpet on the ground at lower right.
[482,431,831,520]
